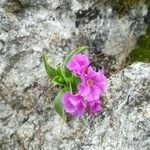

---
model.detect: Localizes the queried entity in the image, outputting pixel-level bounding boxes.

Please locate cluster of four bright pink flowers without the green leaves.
[62,54,107,116]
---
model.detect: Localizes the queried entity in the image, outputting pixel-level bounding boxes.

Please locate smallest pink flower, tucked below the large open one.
[87,100,102,114]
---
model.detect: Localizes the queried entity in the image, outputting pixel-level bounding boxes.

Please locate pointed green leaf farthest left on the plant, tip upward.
[43,54,56,79]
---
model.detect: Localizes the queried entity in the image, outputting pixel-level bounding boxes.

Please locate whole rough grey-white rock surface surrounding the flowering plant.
[0,0,150,150]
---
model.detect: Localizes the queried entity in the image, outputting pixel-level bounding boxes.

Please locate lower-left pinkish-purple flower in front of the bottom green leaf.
[62,92,85,116]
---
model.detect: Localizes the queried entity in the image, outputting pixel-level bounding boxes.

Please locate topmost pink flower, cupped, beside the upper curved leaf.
[67,54,90,76]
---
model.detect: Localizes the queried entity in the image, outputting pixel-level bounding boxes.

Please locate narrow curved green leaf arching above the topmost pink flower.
[62,46,88,69]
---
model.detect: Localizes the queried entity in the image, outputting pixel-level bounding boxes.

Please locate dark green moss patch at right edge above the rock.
[128,25,150,62]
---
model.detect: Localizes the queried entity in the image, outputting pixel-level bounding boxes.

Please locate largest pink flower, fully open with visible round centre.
[78,67,107,101]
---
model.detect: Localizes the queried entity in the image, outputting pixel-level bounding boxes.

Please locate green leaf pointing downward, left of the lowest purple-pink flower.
[54,90,66,120]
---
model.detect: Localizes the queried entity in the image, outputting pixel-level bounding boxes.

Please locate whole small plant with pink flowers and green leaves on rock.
[43,47,107,120]
